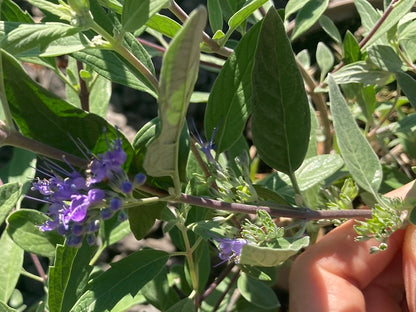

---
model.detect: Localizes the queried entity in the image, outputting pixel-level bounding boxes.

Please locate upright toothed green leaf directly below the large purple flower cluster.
[48,243,97,312]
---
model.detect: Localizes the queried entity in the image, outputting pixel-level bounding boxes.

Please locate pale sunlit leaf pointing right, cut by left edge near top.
[0,22,79,55]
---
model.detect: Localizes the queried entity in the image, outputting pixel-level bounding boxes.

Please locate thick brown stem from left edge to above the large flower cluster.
[0,125,88,168]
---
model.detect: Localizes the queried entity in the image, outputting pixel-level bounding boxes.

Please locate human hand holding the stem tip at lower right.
[289,182,416,312]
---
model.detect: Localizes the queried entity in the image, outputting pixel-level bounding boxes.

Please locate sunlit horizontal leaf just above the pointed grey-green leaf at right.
[332,62,394,86]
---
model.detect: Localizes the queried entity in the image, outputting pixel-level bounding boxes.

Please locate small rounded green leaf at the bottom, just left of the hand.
[237,273,280,309]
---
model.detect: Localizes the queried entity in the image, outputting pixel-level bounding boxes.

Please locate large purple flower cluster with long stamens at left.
[32,138,146,247]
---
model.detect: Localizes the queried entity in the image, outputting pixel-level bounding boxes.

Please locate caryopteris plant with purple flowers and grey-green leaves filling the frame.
[0,0,416,312]
